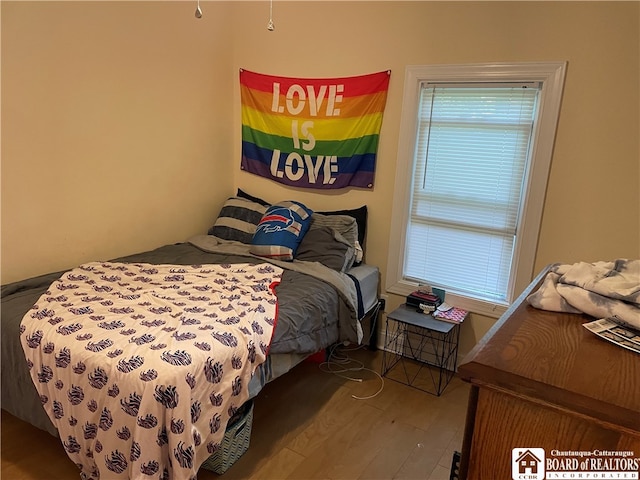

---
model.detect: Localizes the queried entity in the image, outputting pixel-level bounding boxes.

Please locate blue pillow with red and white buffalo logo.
[249,201,313,261]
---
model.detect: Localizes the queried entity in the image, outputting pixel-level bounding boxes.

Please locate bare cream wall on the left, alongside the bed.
[2,2,233,283]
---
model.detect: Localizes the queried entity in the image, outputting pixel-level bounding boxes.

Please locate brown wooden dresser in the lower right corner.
[458,270,640,480]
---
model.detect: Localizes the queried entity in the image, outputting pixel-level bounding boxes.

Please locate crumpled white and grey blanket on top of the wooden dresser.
[527,259,640,330]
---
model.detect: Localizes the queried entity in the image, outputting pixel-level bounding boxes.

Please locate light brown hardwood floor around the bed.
[1,349,469,480]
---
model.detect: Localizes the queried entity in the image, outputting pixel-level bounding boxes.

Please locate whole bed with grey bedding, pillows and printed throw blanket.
[1,192,379,479]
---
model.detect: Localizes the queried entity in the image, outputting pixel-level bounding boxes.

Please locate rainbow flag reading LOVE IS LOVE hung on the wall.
[240,70,391,188]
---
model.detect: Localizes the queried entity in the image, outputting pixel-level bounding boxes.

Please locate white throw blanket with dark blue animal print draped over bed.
[20,262,282,480]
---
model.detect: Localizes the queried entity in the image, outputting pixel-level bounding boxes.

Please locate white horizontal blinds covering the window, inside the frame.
[404,84,540,301]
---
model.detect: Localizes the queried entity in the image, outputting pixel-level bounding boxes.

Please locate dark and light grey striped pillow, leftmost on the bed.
[207,197,267,244]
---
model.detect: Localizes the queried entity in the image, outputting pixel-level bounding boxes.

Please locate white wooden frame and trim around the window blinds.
[386,62,567,318]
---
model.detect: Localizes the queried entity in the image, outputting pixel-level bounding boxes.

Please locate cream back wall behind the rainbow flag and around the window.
[234,1,640,352]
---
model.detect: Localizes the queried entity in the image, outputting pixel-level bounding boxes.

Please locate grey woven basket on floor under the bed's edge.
[202,400,253,474]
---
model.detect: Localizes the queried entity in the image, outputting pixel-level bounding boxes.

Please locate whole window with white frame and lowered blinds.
[387,63,565,316]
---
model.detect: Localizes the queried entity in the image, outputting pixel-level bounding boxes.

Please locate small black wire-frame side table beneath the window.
[382,304,460,396]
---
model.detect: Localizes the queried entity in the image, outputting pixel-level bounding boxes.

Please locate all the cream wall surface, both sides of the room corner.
[1,0,640,351]
